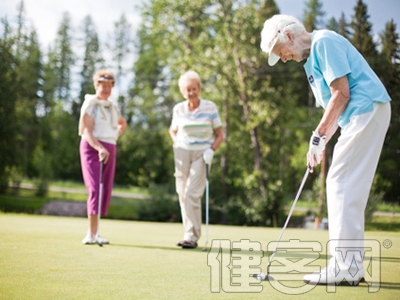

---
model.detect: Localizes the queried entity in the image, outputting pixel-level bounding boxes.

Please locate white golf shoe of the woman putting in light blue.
[303,266,364,286]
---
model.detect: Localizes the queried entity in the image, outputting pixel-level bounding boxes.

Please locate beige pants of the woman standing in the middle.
[174,148,206,242]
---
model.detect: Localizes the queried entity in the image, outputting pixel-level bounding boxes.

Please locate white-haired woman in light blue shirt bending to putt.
[261,15,391,285]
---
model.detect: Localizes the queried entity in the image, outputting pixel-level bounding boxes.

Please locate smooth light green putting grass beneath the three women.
[0,213,400,300]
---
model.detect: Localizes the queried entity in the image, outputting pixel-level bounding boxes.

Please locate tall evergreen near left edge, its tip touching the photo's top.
[14,1,46,183]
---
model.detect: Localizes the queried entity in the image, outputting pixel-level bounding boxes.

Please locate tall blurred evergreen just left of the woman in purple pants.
[44,12,81,179]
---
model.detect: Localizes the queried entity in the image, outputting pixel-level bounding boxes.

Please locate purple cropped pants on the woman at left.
[79,139,117,216]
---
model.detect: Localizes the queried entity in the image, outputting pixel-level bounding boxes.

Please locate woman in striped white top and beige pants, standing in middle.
[169,71,223,248]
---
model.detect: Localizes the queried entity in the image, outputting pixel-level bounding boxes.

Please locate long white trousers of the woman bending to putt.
[326,103,391,270]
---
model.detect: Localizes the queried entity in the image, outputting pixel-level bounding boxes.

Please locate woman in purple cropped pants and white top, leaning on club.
[79,70,127,244]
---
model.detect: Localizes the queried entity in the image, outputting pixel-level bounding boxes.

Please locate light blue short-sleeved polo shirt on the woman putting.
[304,30,390,128]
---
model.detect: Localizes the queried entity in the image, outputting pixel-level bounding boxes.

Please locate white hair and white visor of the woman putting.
[260,15,306,66]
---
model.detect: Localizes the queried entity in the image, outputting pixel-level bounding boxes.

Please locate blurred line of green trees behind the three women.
[0,0,400,226]
